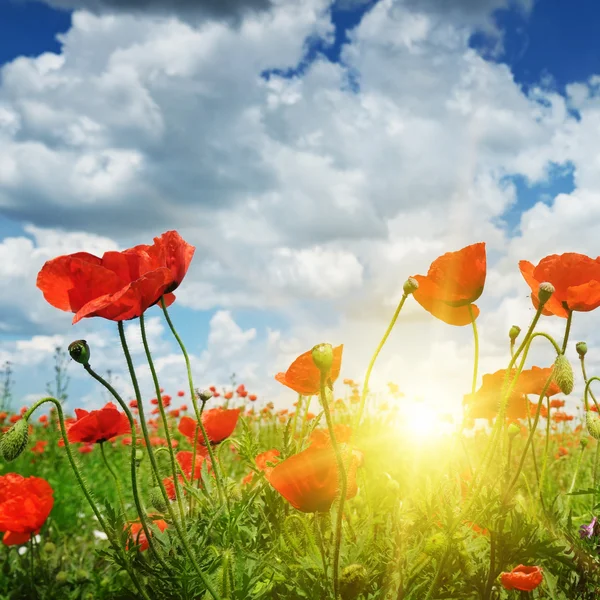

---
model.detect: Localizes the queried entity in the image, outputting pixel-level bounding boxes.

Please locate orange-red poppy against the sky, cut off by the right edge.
[519,252,600,319]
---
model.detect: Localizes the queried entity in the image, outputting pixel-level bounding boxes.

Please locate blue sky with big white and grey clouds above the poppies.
[0,0,600,420]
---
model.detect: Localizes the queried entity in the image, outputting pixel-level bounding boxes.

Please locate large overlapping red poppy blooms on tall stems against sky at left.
[37,231,195,324]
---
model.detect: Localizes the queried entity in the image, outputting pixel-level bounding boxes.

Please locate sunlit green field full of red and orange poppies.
[0,231,600,600]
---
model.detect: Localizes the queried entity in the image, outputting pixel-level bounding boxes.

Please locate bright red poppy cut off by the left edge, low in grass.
[0,473,54,546]
